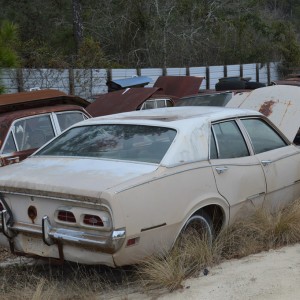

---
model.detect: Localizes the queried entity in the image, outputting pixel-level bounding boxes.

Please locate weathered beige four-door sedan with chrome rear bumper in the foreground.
[0,107,300,267]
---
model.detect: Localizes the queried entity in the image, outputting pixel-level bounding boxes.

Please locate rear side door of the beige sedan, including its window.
[210,120,266,217]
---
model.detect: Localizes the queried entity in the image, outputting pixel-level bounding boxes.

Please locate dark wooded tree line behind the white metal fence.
[0,0,300,69]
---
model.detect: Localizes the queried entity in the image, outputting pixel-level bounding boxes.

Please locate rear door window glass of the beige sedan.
[211,121,249,159]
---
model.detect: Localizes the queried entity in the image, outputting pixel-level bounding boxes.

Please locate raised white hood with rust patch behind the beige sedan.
[226,85,300,141]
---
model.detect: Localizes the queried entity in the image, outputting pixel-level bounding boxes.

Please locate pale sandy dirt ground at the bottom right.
[0,244,300,300]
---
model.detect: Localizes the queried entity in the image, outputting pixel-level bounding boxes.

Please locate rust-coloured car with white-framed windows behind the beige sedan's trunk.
[0,90,90,167]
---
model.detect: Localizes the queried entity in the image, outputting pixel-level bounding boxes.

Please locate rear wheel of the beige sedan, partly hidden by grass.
[181,212,214,245]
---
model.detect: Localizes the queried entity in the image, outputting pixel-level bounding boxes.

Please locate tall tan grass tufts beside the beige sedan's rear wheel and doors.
[138,200,300,291]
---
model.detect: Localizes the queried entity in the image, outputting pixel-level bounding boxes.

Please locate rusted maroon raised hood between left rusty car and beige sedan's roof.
[86,88,159,117]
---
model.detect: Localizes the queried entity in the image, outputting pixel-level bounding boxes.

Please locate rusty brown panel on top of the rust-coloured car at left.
[0,89,89,113]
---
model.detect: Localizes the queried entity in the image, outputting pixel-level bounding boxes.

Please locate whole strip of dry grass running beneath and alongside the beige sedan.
[0,200,300,300]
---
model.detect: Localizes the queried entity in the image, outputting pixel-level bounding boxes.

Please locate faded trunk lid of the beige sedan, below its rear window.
[0,156,158,201]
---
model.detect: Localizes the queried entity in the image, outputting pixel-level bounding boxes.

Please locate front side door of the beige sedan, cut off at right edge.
[241,118,300,208]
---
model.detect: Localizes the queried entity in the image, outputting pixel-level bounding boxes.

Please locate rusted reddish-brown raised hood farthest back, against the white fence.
[154,76,203,98]
